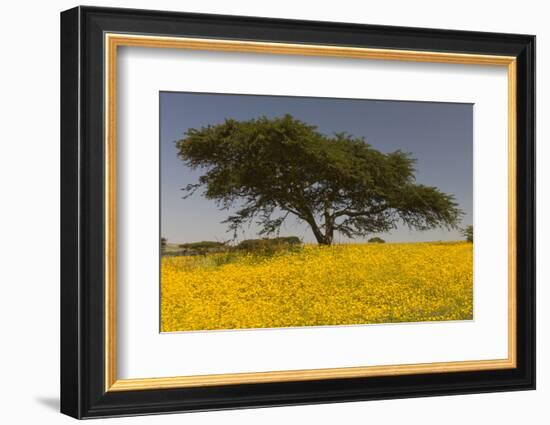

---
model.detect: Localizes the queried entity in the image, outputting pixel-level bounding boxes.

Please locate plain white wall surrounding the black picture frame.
[0,0,550,425]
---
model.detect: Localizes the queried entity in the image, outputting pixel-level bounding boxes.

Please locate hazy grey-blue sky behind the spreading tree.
[160,92,473,243]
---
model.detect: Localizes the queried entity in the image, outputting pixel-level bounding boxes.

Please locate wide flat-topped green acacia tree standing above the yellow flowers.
[176,115,462,245]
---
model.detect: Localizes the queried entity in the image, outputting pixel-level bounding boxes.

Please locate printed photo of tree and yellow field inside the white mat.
[159,91,474,332]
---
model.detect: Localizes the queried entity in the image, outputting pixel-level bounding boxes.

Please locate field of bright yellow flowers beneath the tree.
[161,242,473,332]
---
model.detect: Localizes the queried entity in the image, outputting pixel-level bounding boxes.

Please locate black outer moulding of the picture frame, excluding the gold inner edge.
[61,7,535,418]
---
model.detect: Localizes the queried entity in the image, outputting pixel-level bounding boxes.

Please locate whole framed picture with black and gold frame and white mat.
[61,7,535,418]
